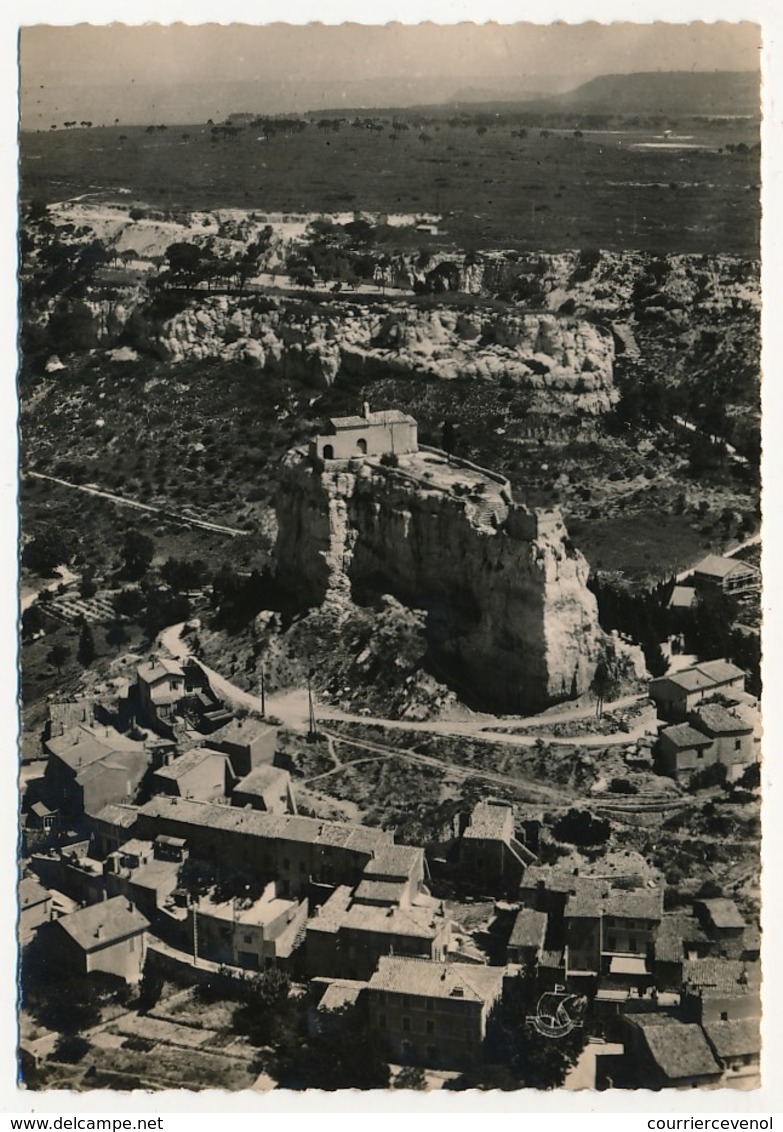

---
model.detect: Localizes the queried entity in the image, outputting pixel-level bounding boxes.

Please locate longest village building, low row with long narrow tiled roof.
[137,796,394,897]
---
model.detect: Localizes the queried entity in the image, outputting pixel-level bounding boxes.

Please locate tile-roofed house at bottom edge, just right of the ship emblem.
[623,1014,722,1089]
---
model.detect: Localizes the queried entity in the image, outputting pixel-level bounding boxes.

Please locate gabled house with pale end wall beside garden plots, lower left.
[49,897,149,983]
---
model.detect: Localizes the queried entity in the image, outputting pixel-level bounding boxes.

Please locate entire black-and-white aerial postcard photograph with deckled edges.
[9,9,775,1110]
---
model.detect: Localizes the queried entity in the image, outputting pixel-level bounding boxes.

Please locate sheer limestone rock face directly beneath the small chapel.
[276,451,603,712]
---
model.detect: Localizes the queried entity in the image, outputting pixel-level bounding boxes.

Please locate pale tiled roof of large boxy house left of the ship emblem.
[369,955,506,1004]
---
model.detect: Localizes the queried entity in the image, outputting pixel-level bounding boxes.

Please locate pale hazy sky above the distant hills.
[21,23,759,86]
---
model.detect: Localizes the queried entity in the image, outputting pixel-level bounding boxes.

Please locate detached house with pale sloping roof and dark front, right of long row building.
[459,799,536,893]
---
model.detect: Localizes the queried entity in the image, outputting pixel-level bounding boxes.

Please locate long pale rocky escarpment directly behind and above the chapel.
[139,297,616,412]
